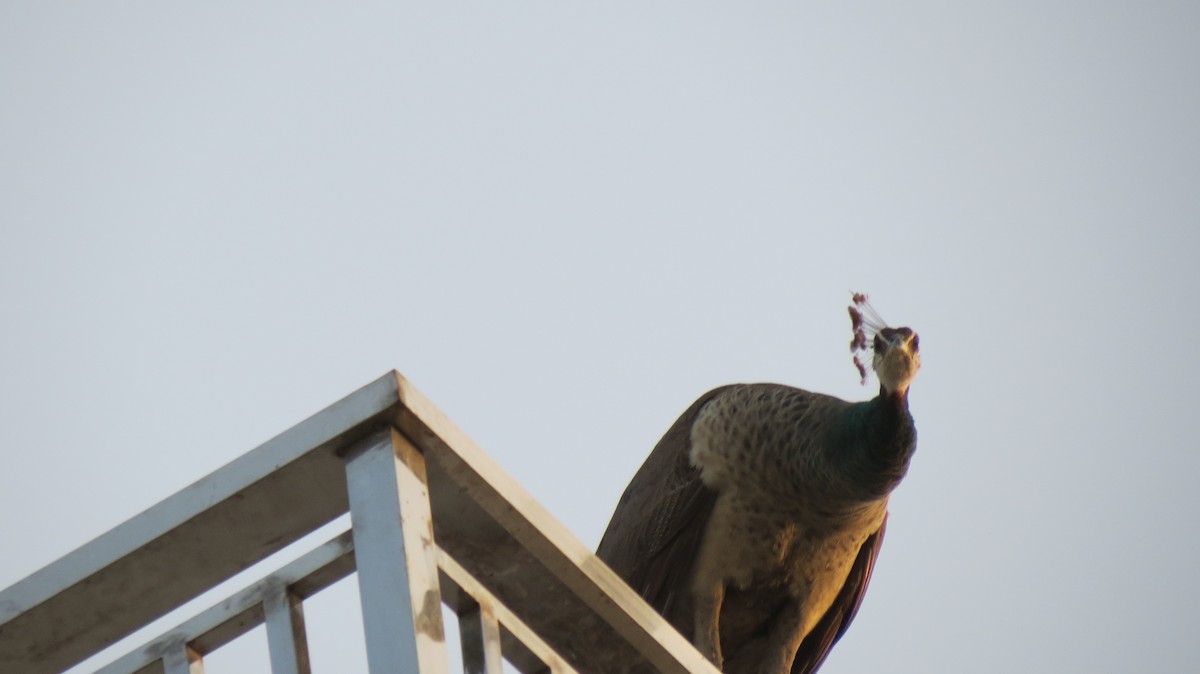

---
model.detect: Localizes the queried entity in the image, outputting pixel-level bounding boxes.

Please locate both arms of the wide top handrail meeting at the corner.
[0,373,716,674]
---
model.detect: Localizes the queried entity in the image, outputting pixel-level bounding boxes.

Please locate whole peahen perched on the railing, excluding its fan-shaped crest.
[598,329,919,674]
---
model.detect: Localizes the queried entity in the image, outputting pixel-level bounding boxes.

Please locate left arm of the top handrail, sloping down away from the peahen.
[0,374,397,674]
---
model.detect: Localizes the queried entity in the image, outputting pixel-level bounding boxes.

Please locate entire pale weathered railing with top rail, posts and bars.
[0,372,716,674]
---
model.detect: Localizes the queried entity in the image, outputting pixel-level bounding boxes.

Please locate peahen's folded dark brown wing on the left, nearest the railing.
[596,386,730,633]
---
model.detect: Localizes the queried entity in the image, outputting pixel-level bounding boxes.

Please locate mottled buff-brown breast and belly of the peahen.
[690,385,887,603]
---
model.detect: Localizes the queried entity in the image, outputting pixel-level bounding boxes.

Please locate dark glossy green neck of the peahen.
[830,391,917,500]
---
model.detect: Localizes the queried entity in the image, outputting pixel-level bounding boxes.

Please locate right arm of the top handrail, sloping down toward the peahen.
[395,375,718,674]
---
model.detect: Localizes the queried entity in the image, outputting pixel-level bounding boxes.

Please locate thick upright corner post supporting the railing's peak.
[346,428,449,674]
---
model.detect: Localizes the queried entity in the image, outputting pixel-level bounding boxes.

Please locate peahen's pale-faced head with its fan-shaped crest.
[850,293,920,398]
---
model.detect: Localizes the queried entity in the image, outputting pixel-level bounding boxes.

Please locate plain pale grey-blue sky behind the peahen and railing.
[0,5,1200,674]
